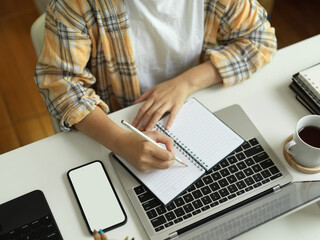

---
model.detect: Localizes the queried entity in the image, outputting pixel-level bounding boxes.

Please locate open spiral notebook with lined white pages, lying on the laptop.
[116,98,244,205]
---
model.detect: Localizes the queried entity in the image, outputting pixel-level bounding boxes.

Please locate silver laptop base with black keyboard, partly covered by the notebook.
[110,105,292,240]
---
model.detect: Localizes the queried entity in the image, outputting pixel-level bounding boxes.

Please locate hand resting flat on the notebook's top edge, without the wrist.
[132,77,189,131]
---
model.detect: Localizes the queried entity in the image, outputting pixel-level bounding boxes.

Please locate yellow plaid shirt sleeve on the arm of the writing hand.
[35,1,108,131]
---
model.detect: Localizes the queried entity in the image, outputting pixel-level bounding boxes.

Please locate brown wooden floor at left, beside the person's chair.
[0,0,54,153]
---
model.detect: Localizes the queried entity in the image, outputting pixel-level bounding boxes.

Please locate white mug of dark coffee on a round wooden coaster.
[285,115,320,168]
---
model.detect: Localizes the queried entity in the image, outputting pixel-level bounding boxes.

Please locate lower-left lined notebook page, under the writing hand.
[117,145,204,205]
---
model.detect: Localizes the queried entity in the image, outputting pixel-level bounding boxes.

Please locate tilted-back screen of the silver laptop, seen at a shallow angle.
[180,182,320,240]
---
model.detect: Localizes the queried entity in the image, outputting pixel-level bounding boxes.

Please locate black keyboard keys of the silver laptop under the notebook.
[134,138,282,232]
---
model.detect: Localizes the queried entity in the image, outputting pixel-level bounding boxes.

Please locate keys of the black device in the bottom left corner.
[0,215,62,240]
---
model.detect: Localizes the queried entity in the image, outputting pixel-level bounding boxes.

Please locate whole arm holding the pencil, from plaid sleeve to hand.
[35,1,174,171]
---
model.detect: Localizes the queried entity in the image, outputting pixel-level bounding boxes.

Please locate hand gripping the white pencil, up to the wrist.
[115,131,175,172]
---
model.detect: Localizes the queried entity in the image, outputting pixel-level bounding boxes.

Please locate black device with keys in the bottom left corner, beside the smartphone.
[0,190,63,240]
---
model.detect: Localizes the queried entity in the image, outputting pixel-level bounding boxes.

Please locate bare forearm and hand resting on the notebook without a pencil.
[132,60,222,131]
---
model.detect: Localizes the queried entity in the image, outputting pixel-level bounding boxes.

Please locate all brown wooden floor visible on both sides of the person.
[0,0,320,154]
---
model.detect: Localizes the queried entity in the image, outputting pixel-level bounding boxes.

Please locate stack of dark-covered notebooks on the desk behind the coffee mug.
[289,63,320,115]
